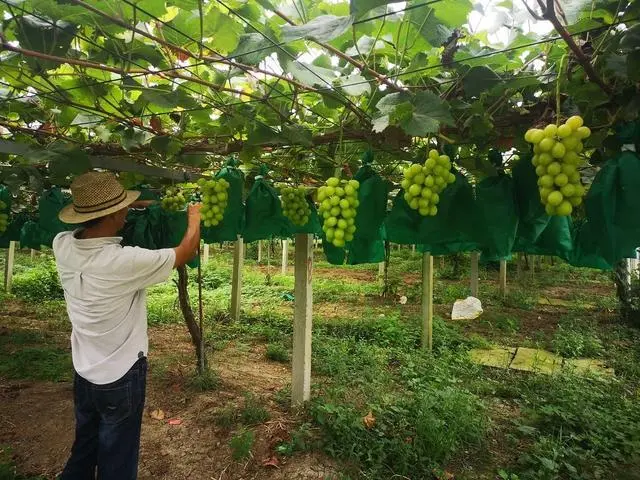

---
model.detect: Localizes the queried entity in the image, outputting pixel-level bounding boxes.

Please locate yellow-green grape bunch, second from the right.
[402,149,456,217]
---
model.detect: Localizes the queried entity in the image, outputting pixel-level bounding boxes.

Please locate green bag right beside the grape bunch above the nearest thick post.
[347,158,388,265]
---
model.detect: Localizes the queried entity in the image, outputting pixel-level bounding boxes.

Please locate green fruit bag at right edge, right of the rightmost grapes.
[585,151,640,265]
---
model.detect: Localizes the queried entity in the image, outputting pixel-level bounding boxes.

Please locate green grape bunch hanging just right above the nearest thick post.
[318,177,360,247]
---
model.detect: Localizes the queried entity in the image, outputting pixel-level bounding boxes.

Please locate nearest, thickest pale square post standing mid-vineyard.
[291,233,313,407]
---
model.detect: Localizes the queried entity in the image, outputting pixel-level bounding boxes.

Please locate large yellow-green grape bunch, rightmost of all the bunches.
[524,115,591,216]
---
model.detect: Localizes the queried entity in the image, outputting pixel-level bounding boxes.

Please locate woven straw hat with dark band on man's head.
[58,172,140,224]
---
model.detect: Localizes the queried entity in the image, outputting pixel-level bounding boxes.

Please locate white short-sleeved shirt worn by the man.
[53,232,175,385]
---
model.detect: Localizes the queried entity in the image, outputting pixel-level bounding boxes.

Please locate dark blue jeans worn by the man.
[60,357,147,480]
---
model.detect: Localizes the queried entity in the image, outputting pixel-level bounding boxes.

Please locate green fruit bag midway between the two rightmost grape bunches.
[476,174,518,261]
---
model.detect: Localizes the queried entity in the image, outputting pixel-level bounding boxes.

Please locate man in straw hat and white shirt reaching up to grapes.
[53,172,200,480]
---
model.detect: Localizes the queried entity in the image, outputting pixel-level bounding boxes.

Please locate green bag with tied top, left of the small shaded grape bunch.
[242,167,292,242]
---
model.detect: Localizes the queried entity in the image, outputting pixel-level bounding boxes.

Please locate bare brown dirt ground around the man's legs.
[0,326,335,480]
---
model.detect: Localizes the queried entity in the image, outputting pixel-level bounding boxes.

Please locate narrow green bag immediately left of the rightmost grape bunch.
[512,153,550,253]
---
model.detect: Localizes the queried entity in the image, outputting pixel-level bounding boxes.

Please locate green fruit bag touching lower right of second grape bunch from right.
[418,169,478,255]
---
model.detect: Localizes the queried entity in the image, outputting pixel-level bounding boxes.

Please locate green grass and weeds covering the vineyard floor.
[5,248,640,480]
